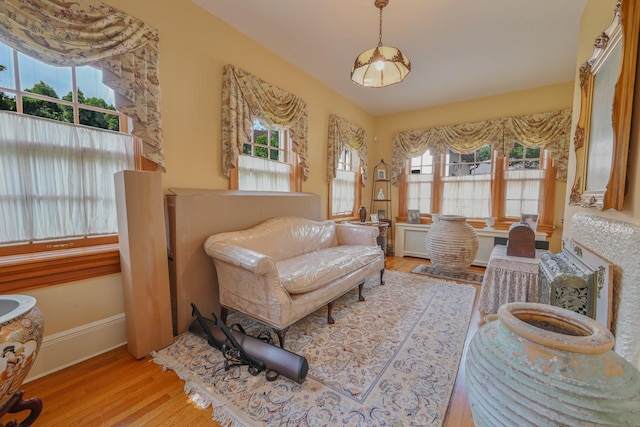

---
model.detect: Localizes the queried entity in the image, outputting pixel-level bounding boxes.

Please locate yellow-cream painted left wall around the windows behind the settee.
[25,0,374,375]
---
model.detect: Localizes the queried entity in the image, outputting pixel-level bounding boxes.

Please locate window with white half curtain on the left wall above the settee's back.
[237,119,294,191]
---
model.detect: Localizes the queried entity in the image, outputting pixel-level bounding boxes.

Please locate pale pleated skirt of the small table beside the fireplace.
[478,245,548,313]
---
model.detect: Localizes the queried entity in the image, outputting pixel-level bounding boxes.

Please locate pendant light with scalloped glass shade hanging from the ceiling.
[351,0,411,87]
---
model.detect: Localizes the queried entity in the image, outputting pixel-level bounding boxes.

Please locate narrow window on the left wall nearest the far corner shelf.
[330,148,362,219]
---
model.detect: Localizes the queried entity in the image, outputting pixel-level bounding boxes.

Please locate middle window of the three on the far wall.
[440,145,491,218]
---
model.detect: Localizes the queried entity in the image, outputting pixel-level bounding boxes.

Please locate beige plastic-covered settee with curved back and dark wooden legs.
[204,217,384,348]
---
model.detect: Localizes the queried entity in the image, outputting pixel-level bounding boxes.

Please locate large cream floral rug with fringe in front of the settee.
[153,270,475,426]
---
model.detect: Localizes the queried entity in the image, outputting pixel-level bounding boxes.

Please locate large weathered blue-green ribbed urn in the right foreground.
[465,303,640,427]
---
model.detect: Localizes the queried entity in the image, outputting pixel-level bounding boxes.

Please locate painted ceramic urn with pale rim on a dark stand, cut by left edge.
[0,295,44,408]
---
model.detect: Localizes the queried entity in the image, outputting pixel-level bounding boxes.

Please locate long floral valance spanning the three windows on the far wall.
[391,109,571,185]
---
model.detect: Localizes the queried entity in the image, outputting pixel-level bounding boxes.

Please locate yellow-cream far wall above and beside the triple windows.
[376,82,574,250]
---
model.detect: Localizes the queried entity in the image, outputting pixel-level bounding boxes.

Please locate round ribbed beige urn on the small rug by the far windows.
[426,215,479,271]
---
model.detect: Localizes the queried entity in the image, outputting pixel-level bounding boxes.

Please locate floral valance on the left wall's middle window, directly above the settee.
[222,65,309,181]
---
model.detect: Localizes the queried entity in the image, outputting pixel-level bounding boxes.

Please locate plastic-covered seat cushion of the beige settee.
[277,246,383,294]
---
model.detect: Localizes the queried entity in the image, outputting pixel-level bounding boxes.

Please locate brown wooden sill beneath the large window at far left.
[0,243,120,293]
